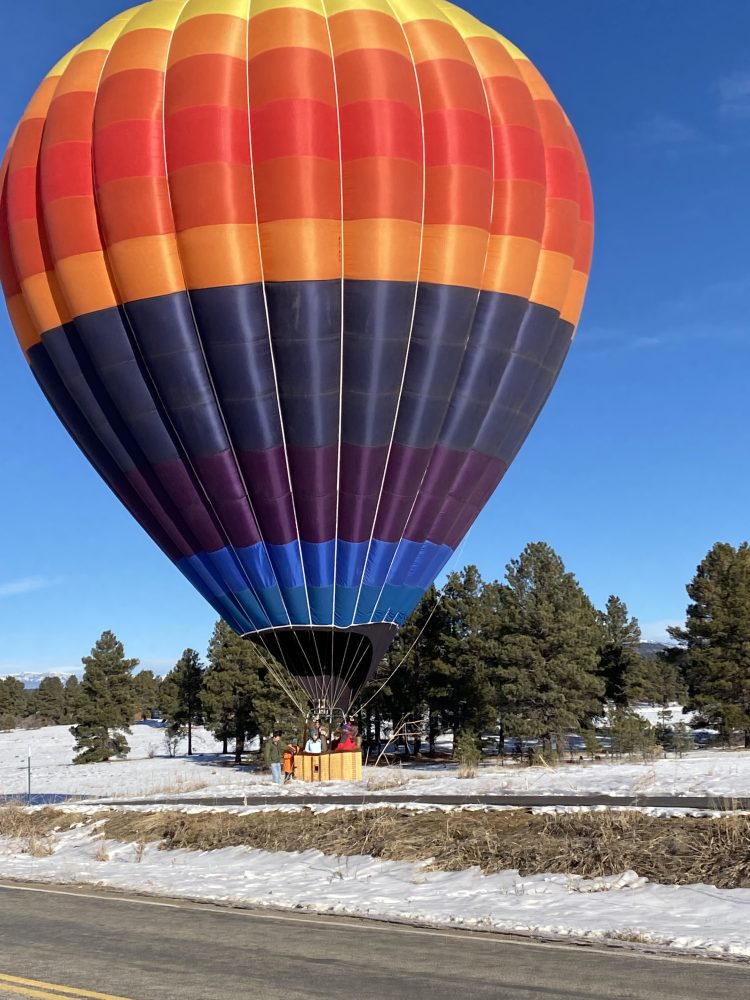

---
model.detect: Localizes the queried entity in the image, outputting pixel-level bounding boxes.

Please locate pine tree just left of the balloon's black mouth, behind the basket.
[201,619,295,764]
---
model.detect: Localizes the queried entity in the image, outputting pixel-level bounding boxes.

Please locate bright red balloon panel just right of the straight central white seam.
[340,101,422,163]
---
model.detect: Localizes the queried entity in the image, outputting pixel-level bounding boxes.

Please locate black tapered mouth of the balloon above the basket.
[243,622,398,712]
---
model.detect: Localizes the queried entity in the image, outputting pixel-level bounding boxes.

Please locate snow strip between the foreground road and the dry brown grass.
[0,827,750,957]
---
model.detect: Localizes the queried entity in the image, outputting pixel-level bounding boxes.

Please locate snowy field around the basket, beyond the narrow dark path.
[0,723,750,800]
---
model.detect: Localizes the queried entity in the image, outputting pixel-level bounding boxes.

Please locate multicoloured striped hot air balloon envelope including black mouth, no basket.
[0,0,592,709]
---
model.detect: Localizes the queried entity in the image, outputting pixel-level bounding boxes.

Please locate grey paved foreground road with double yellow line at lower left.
[0,884,750,1000]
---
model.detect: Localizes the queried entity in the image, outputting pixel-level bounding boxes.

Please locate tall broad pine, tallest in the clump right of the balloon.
[494,542,604,745]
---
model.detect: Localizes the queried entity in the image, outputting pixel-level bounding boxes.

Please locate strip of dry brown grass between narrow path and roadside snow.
[95,809,750,888]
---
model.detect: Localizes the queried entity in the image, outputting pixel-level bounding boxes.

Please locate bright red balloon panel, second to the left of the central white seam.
[165,107,250,172]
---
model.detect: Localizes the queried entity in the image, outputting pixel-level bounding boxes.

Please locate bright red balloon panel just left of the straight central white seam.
[250,100,339,163]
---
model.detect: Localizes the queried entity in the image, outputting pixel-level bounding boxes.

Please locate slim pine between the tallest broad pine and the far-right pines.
[599,594,656,708]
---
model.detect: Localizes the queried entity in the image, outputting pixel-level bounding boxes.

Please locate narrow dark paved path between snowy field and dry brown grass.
[106,789,750,812]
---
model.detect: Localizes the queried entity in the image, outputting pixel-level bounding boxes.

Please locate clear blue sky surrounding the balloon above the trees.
[0,0,750,675]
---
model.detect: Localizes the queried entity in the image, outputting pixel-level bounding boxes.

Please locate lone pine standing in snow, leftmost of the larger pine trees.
[70,631,138,764]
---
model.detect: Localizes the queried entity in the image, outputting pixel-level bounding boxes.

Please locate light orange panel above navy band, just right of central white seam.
[344,219,427,281]
